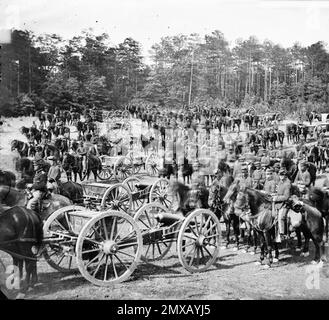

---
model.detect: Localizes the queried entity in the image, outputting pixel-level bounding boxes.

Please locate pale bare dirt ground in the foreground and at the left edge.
[0,115,329,300]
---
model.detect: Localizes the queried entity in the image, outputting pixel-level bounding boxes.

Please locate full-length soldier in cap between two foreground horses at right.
[273,169,291,242]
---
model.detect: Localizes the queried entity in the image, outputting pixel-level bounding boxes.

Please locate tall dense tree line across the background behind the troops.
[0,29,329,113]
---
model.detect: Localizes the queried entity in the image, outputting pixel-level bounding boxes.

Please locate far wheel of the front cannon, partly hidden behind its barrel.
[134,202,178,262]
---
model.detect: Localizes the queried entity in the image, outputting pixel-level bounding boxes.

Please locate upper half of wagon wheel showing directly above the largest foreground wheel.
[101,183,132,214]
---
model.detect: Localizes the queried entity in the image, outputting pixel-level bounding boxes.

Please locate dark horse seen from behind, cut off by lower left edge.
[0,206,43,289]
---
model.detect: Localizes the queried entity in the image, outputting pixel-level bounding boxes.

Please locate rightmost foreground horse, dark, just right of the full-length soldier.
[286,196,324,263]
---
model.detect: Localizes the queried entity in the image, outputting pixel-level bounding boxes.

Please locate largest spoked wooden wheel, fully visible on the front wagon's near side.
[76,210,143,287]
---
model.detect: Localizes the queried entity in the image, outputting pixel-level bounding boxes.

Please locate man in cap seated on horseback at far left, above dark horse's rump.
[26,159,47,211]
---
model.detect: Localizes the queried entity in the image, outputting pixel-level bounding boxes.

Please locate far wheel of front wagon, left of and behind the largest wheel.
[43,205,86,272]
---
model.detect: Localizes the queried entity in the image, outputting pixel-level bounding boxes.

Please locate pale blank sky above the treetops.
[0,0,329,62]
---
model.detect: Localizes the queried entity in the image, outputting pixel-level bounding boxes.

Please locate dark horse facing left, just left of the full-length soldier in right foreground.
[224,180,279,266]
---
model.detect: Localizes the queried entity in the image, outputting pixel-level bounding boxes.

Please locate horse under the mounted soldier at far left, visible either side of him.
[0,186,72,220]
